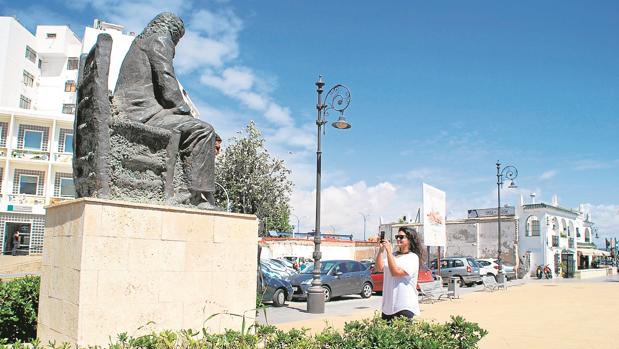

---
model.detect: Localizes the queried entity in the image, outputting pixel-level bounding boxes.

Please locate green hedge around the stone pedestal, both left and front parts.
[0,277,487,349]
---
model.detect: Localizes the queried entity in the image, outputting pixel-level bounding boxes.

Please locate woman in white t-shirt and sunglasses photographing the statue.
[376,227,424,322]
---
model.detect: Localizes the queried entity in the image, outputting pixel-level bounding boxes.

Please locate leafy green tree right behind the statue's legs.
[215,121,292,236]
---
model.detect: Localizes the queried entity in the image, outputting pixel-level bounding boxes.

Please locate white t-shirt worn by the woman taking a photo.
[382,252,421,315]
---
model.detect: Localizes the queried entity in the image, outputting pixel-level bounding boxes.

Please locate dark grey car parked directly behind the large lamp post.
[291,260,374,302]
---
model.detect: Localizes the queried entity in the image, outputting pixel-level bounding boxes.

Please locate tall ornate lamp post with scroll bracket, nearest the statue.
[307,76,350,314]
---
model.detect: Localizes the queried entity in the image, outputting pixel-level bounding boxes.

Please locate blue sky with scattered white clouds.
[6,0,619,242]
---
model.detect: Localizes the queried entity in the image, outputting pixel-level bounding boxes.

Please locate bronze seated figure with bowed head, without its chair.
[113,12,216,209]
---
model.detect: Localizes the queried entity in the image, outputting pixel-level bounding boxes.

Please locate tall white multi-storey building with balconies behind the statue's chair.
[0,17,82,254]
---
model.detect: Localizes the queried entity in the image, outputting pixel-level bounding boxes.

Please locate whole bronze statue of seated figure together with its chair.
[74,12,216,209]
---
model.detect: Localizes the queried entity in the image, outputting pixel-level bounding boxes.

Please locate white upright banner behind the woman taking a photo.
[423,183,447,246]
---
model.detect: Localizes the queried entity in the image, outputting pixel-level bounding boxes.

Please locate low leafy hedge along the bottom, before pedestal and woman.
[0,317,487,349]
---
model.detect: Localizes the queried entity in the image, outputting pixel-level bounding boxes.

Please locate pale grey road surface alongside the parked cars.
[257,280,522,324]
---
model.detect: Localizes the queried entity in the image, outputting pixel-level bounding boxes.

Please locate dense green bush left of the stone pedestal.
[0,276,40,343]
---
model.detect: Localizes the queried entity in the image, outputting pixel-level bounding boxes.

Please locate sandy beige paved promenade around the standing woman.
[276,277,619,349]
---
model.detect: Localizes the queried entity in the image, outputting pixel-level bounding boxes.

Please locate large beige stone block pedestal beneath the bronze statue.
[37,198,258,346]
